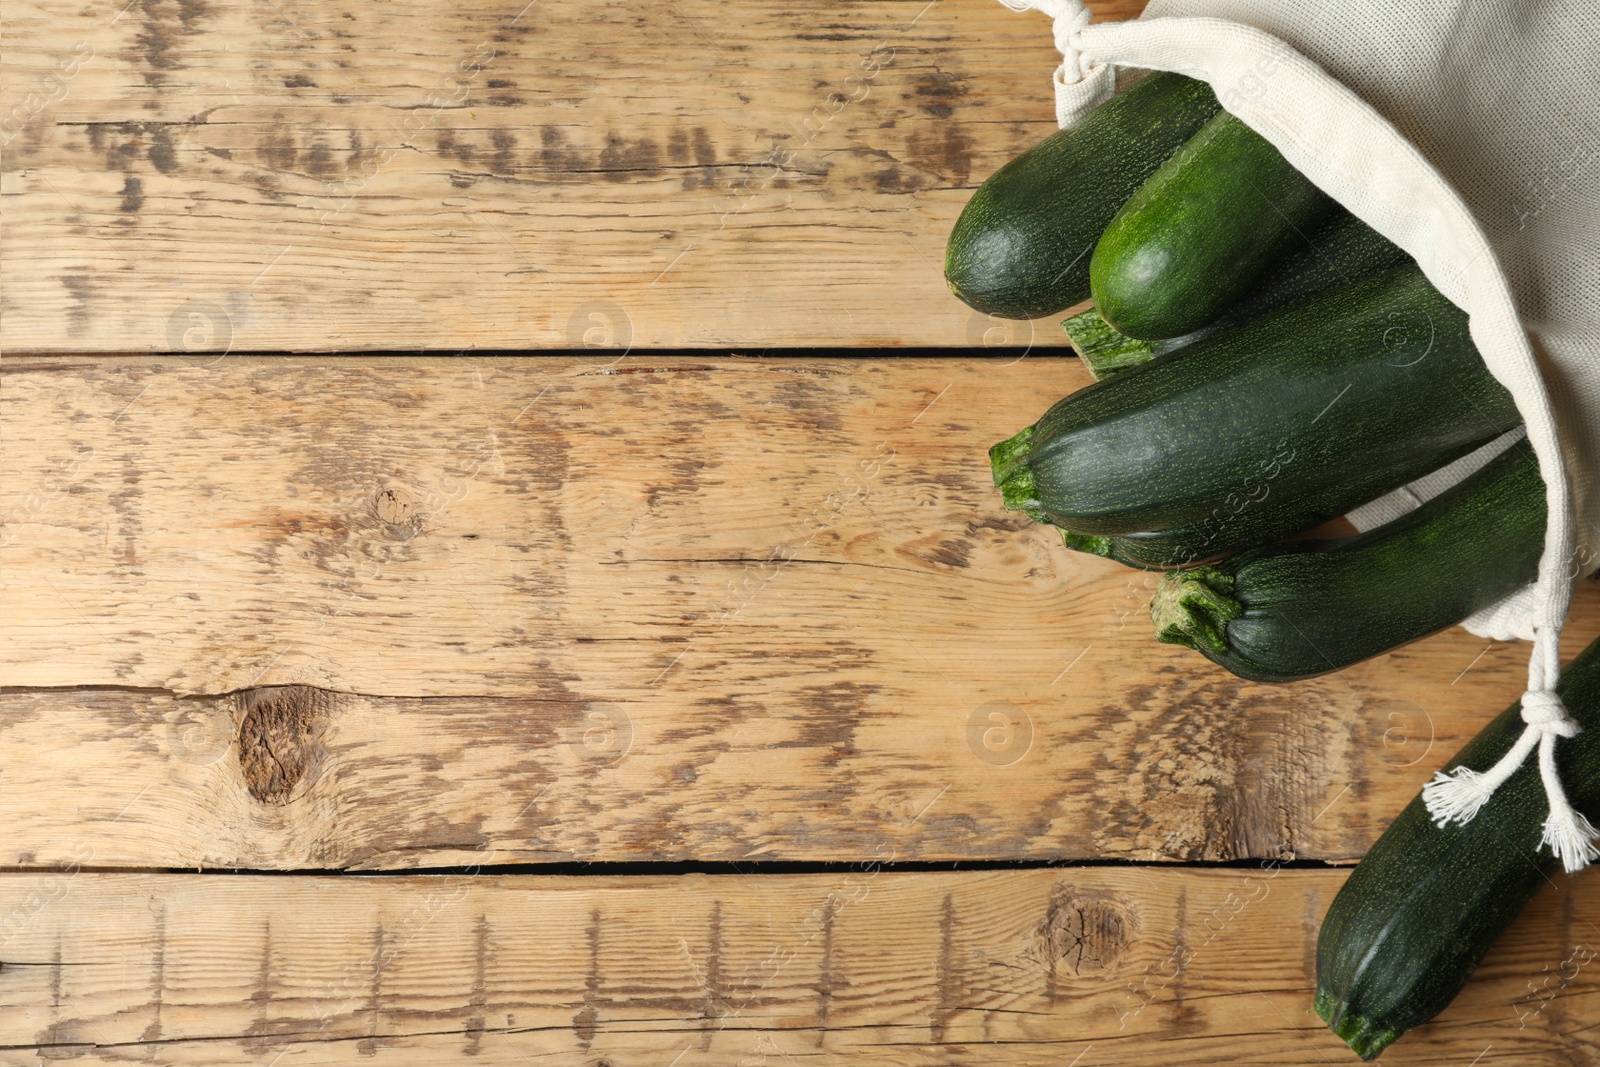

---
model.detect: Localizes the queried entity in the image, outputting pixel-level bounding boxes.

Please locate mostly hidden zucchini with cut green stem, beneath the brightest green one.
[1061,208,1410,381]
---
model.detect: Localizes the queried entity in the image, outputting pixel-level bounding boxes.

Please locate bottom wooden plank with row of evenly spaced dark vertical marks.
[0,867,1600,1067]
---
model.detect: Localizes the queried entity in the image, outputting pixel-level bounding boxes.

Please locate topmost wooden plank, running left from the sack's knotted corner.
[0,0,1142,352]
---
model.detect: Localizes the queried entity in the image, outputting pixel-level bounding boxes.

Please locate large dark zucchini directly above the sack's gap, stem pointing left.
[990,267,1520,553]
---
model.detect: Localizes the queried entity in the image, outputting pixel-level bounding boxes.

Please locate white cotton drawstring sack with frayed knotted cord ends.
[1002,0,1600,870]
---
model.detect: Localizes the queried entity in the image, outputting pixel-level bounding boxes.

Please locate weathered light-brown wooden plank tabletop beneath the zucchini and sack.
[0,0,1600,1067]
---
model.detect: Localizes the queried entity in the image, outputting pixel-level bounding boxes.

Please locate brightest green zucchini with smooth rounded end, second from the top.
[1090,112,1336,341]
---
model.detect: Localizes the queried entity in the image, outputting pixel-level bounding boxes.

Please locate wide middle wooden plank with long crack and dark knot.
[0,357,1600,869]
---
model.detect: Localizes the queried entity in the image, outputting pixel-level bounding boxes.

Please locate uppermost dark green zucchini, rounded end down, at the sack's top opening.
[944,72,1218,318]
